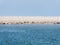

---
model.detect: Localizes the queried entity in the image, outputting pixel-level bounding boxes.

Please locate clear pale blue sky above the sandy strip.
[0,0,60,16]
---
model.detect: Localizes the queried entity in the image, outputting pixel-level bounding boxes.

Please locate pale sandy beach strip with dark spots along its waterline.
[0,16,60,24]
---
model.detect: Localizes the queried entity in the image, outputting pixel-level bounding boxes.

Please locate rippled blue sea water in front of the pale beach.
[0,24,60,45]
